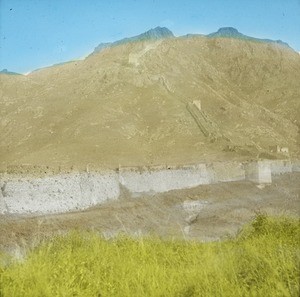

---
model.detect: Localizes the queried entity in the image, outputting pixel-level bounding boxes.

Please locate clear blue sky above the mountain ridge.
[0,0,300,73]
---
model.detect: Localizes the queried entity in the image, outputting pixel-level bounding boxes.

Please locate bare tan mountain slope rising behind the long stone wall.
[0,29,300,168]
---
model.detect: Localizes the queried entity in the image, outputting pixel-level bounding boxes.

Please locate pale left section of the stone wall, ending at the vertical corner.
[0,172,120,214]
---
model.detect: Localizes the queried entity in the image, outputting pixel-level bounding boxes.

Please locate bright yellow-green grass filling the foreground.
[0,215,300,297]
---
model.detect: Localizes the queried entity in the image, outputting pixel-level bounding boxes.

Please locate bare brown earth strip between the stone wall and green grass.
[0,172,300,256]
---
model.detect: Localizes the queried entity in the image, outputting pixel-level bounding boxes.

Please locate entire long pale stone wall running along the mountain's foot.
[0,159,300,215]
